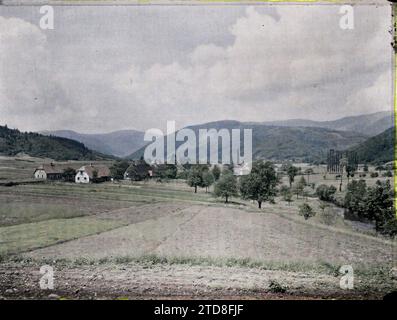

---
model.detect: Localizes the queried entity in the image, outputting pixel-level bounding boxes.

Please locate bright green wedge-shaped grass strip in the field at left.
[0,217,124,255]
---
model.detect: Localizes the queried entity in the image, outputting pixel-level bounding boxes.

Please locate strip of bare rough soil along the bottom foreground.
[0,263,391,299]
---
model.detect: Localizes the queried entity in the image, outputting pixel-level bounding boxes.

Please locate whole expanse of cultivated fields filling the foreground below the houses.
[0,158,395,299]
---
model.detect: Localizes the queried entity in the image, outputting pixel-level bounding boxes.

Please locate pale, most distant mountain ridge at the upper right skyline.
[263,111,393,136]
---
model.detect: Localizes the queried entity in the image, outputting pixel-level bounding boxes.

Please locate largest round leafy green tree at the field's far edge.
[240,161,278,208]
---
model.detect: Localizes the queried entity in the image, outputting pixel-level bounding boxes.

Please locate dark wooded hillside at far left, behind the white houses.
[0,126,108,160]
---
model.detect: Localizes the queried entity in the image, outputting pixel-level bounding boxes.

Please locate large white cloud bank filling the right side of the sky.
[116,6,391,125]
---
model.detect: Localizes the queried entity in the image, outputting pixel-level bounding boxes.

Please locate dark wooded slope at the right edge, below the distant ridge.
[351,128,395,164]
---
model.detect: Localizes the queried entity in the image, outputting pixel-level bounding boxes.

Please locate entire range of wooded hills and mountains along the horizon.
[0,111,394,162]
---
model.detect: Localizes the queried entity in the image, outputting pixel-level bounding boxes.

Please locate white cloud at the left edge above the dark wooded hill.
[0,17,75,129]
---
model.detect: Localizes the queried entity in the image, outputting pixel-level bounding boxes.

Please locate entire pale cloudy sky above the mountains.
[0,5,392,132]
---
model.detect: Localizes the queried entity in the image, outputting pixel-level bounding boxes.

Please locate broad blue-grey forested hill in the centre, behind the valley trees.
[128,121,367,161]
